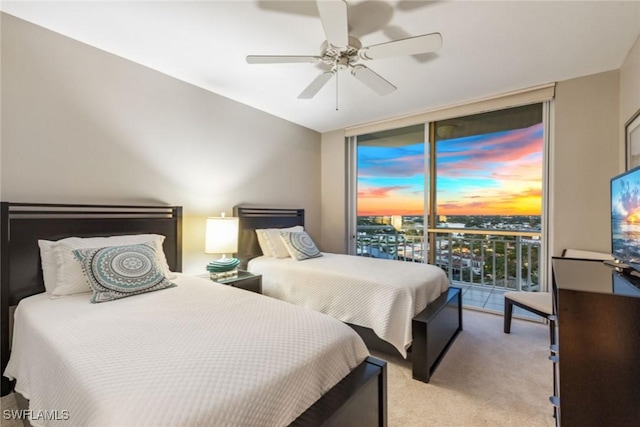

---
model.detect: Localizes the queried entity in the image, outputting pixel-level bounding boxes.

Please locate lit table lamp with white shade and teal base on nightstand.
[204,213,240,279]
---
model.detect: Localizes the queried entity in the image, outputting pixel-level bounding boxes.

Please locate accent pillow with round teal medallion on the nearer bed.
[73,244,176,303]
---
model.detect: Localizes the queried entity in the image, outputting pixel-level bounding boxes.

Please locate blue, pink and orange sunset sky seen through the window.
[358,124,543,216]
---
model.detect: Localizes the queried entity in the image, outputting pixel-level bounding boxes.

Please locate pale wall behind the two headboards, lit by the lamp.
[0,14,320,273]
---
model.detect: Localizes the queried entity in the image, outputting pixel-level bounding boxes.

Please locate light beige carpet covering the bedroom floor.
[0,310,554,427]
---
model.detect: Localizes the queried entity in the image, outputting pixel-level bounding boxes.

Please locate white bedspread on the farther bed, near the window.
[248,253,449,357]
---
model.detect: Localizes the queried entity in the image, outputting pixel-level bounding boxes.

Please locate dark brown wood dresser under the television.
[551,258,640,427]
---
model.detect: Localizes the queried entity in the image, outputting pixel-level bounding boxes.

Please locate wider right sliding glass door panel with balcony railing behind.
[430,104,544,302]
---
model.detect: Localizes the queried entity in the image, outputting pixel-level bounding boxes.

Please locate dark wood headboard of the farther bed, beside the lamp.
[233,206,304,268]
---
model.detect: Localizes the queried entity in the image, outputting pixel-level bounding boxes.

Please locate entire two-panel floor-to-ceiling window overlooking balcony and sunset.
[353,103,545,311]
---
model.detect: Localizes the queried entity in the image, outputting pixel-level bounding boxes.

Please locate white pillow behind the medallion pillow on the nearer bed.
[41,234,175,297]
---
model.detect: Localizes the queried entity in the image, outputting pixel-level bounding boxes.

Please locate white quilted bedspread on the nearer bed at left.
[5,275,368,427]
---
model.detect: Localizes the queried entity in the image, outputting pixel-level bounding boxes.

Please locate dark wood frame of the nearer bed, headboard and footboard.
[0,202,387,427]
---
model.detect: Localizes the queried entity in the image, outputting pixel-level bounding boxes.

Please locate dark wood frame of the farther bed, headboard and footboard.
[233,205,462,383]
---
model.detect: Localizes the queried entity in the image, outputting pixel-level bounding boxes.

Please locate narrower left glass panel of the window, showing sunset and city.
[356,125,428,259]
